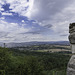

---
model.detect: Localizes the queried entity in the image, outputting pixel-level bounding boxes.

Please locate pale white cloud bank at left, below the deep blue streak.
[0,19,31,42]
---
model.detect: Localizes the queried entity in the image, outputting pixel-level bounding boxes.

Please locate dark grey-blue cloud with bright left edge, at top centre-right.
[28,0,74,21]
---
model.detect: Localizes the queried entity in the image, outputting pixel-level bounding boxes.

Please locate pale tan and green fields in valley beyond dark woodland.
[31,45,71,53]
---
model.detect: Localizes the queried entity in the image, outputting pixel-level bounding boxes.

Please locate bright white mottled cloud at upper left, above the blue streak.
[6,0,34,17]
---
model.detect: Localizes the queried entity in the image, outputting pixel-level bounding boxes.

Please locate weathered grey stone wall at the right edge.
[67,23,75,75]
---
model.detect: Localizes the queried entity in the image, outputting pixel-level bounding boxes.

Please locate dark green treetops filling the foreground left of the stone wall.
[0,48,70,75]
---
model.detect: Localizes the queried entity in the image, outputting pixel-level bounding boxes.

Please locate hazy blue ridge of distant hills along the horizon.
[3,41,70,47]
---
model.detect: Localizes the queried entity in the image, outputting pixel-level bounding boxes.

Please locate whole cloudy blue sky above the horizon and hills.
[0,0,75,42]
